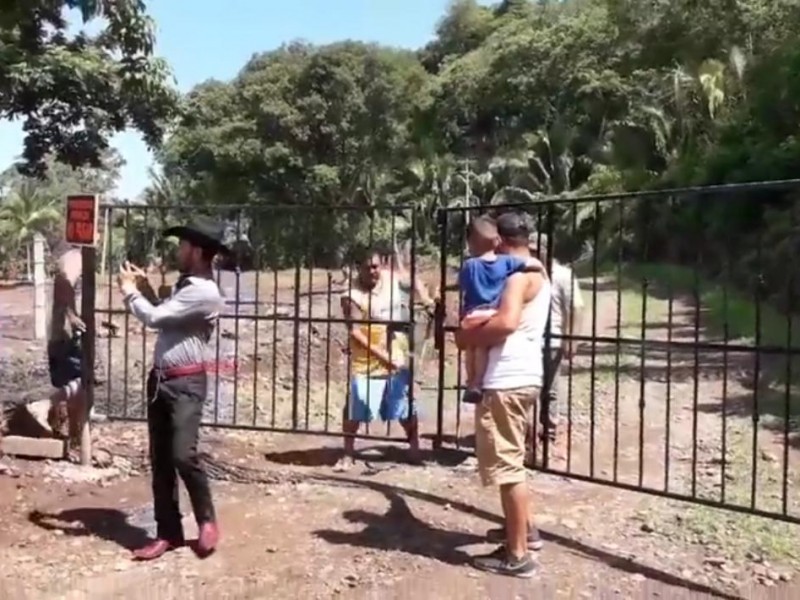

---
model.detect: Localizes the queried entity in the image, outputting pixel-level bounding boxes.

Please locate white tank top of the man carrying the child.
[483,280,551,390]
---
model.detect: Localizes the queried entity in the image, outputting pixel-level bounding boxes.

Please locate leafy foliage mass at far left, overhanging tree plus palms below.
[0,0,179,278]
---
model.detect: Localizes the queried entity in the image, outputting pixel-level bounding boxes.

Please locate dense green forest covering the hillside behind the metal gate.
[1,0,800,299]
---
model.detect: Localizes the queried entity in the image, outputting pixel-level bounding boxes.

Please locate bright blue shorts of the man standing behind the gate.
[347,369,416,423]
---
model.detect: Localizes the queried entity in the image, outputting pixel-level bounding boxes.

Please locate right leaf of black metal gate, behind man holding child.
[436,181,800,523]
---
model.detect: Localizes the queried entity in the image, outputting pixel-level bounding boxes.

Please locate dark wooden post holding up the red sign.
[81,246,97,465]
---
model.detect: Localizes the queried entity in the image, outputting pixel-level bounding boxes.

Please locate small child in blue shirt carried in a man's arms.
[458,216,544,404]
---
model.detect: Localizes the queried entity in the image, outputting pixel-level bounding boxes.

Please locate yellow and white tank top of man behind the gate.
[346,277,408,377]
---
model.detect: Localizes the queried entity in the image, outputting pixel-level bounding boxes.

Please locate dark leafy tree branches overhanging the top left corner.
[0,0,177,174]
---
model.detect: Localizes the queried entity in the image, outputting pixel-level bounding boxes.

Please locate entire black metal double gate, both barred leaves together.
[85,181,800,522]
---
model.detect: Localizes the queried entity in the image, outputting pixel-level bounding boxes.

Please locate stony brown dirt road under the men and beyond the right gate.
[0,274,800,599]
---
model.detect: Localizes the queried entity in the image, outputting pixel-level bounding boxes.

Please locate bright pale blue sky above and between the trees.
[0,0,493,199]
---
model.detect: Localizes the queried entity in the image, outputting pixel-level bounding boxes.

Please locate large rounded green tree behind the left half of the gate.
[161,42,428,262]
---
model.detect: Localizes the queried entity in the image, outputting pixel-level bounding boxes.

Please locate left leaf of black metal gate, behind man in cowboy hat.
[93,204,425,440]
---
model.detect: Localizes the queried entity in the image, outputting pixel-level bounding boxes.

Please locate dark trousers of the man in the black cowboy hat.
[147,371,216,541]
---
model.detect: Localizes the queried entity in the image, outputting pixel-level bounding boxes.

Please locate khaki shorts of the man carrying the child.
[475,387,539,486]
